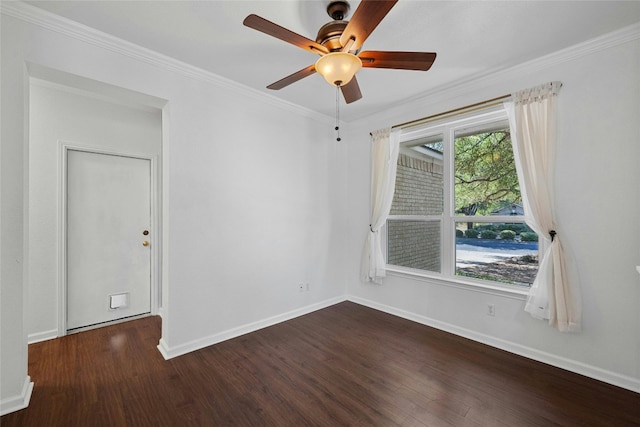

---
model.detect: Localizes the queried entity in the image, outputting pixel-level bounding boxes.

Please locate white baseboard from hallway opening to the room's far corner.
[158,296,346,360]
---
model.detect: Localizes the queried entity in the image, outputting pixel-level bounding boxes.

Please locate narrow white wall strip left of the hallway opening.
[0,10,32,414]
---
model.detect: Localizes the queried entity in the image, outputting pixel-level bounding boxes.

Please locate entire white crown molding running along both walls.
[0,0,640,124]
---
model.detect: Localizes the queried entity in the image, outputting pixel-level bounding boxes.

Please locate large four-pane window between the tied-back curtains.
[386,109,538,287]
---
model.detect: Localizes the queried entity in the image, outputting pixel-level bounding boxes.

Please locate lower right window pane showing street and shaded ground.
[456,222,538,286]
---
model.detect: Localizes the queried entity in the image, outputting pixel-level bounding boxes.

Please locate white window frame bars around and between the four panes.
[381,105,544,298]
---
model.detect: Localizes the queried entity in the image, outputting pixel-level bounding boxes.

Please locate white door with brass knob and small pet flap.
[66,150,153,330]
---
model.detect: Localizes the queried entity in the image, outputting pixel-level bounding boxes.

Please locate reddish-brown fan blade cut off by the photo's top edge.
[340,0,398,52]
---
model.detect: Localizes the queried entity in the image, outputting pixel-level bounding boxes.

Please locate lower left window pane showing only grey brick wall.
[387,220,441,272]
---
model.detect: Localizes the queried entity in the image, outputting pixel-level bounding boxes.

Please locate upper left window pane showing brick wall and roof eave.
[391,135,443,215]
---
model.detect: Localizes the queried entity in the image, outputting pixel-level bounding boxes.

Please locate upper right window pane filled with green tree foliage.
[454,124,524,216]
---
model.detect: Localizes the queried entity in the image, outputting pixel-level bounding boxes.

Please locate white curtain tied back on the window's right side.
[505,82,582,332]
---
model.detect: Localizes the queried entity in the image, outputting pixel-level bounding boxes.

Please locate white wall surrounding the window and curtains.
[347,26,640,392]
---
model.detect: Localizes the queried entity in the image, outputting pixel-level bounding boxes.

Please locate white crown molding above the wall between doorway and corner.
[0,0,335,123]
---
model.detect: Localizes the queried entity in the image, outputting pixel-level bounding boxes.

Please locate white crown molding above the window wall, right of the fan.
[352,22,640,123]
